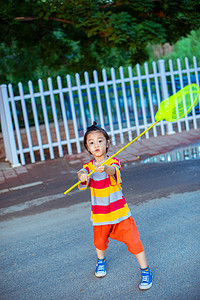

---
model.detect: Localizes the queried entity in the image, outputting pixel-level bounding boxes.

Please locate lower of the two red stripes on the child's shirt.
[92,197,126,214]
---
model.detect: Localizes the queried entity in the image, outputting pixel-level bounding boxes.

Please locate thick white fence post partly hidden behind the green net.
[158,59,175,134]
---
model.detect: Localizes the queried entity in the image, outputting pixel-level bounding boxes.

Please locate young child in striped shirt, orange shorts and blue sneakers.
[78,122,152,290]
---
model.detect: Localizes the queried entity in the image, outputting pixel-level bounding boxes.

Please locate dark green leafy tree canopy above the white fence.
[0,0,200,83]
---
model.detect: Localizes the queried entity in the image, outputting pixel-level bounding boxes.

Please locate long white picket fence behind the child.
[0,57,200,166]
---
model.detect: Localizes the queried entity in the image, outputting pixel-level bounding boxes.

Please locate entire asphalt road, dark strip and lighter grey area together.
[0,160,200,300]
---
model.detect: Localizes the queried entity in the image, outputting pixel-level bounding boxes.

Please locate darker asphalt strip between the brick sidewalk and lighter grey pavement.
[0,159,200,220]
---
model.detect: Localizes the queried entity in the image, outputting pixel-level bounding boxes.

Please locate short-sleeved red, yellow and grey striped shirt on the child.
[78,158,131,225]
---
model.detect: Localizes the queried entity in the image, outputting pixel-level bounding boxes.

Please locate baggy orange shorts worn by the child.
[93,216,144,255]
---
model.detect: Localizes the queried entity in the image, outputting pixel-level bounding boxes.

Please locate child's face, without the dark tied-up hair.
[87,131,108,159]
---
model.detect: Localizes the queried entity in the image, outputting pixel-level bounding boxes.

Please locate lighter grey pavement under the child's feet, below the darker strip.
[0,191,200,300]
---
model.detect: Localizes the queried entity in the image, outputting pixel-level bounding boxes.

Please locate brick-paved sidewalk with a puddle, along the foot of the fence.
[0,129,200,194]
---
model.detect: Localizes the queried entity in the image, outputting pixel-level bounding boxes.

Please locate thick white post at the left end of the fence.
[0,84,21,168]
